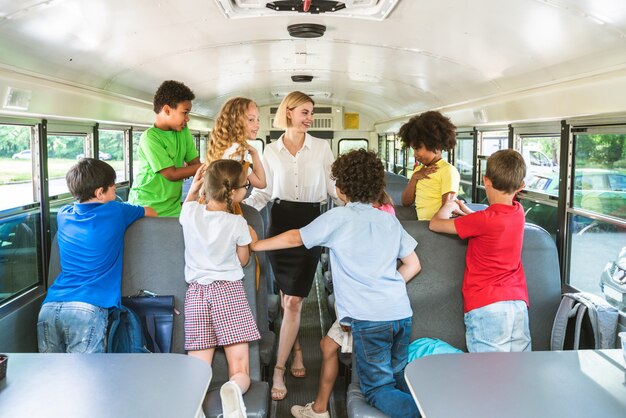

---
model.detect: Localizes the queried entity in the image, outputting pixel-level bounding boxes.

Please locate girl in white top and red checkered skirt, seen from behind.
[180,160,260,418]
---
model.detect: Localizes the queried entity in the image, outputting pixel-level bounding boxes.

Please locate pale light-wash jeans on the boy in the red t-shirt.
[465,300,531,353]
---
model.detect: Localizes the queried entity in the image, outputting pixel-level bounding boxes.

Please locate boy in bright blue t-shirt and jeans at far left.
[37,158,157,353]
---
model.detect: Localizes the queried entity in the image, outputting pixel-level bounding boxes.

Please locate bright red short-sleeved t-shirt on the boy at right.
[454,202,528,312]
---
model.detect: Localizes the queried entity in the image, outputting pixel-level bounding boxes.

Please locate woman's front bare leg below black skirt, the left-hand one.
[272,295,302,400]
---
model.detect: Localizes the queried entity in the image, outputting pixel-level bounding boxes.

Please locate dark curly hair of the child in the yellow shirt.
[398,111,456,152]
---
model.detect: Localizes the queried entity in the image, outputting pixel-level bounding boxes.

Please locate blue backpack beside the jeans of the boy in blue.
[107,305,150,353]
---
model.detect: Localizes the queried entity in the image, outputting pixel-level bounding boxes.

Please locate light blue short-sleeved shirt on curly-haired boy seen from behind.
[300,202,417,321]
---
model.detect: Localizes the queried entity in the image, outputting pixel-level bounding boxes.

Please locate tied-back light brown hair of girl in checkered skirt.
[204,160,246,213]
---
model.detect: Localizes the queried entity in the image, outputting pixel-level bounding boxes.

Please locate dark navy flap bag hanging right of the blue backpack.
[122,291,175,353]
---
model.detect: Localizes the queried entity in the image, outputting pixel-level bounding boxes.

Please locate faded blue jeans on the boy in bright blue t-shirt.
[37,302,109,353]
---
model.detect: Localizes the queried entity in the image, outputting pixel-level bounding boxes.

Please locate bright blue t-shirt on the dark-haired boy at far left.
[44,201,144,308]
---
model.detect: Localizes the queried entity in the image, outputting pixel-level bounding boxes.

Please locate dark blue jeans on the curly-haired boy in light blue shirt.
[352,318,420,418]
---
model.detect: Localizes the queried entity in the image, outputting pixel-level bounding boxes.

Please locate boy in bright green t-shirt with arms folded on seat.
[128,80,201,217]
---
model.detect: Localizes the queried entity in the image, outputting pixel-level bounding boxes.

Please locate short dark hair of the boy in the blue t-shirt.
[65,158,116,202]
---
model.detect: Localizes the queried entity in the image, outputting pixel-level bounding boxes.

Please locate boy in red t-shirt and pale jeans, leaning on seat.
[430,149,531,352]
